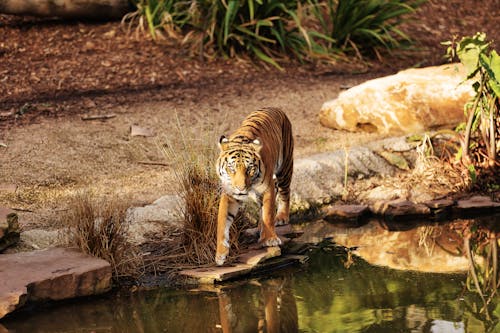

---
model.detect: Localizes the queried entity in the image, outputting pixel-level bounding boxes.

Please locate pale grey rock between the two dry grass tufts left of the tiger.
[126,195,183,245]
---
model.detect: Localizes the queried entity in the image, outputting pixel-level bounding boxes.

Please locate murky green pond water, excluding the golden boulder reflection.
[0,247,500,333]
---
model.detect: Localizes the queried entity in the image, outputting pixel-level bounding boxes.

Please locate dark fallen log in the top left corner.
[0,0,133,20]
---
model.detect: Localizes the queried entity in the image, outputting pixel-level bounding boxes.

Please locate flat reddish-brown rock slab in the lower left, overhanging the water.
[0,248,111,318]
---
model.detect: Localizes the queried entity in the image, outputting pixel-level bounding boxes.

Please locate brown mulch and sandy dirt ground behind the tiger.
[0,0,500,229]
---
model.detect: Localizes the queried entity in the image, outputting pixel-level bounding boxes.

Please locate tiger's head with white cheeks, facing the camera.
[217,136,264,201]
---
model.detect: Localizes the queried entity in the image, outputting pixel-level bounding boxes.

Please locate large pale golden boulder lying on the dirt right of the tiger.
[319,64,474,134]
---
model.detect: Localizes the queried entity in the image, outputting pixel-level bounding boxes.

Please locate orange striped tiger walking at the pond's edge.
[215,107,293,266]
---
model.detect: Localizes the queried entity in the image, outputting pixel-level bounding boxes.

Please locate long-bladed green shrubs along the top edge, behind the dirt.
[125,0,423,68]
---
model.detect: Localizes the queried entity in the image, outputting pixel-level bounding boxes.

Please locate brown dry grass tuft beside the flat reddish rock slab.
[63,191,142,278]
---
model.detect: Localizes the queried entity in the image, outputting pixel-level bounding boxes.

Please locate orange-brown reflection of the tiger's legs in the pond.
[218,277,298,333]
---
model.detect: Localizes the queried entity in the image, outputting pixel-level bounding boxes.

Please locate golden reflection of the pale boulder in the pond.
[298,221,469,273]
